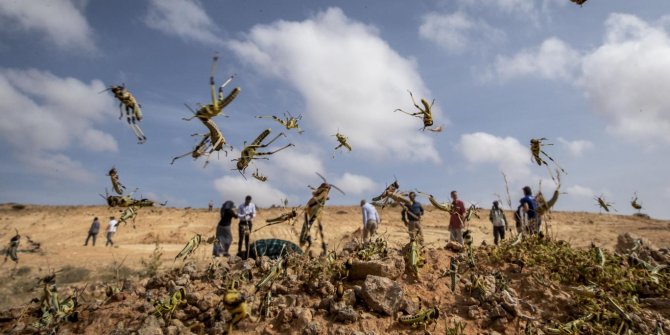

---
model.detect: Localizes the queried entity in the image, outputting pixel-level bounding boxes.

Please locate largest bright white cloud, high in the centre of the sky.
[228,8,446,162]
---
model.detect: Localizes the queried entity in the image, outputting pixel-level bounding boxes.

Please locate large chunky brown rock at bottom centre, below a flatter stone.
[361,276,404,315]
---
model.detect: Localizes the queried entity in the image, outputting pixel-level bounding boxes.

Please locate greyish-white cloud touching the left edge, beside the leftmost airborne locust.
[0,68,118,152]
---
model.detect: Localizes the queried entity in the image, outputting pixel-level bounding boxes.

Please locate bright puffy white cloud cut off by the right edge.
[578,14,670,144]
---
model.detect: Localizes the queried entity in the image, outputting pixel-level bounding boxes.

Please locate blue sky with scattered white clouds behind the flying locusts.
[0,0,670,219]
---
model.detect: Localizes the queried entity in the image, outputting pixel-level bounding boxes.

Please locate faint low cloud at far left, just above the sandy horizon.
[17,152,95,183]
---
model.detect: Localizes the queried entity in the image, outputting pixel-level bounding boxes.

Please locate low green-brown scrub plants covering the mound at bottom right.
[496,236,670,334]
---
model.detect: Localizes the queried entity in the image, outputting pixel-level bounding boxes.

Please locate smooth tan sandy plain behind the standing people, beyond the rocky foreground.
[0,205,670,276]
